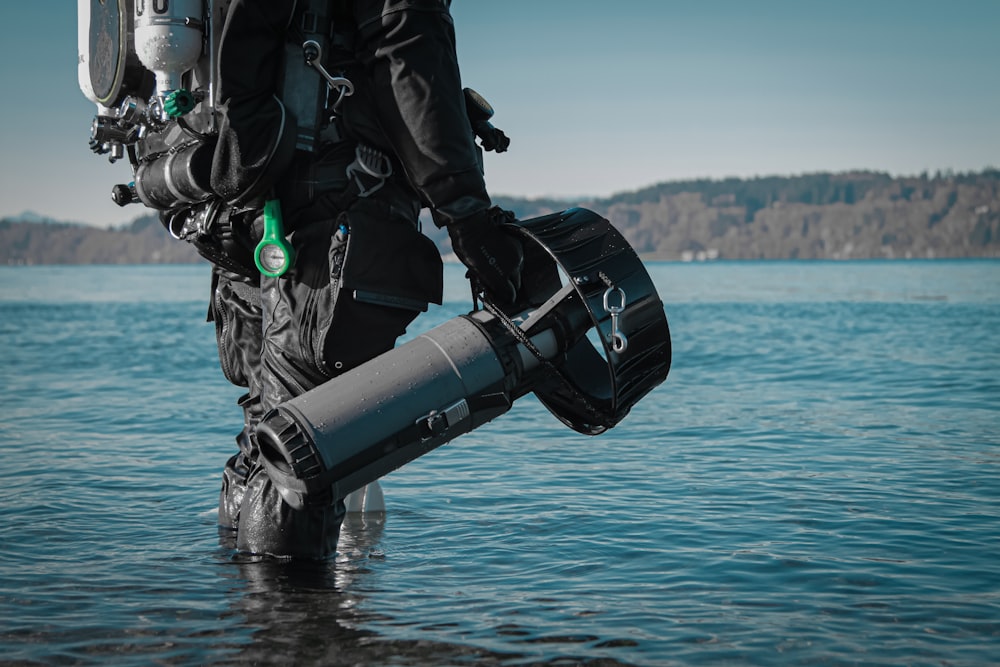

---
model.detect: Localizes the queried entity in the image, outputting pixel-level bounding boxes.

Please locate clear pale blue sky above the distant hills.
[0,0,1000,226]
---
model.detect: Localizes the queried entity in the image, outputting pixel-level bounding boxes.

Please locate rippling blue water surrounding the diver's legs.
[0,261,1000,665]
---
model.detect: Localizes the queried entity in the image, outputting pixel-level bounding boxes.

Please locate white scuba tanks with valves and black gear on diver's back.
[77,0,230,210]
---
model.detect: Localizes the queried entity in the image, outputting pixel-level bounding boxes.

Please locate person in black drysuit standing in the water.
[196,0,523,558]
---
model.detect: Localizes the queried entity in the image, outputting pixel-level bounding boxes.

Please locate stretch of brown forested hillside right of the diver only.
[500,169,1000,260]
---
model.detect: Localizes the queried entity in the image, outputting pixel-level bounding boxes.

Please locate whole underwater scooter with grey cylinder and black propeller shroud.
[254,209,671,509]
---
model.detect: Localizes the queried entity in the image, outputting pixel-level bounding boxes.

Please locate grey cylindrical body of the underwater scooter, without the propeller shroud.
[256,317,519,507]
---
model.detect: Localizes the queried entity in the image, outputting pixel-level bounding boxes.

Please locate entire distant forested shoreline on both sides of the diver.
[0,169,1000,264]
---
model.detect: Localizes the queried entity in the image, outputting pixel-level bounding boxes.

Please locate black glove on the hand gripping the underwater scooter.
[448,206,524,304]
